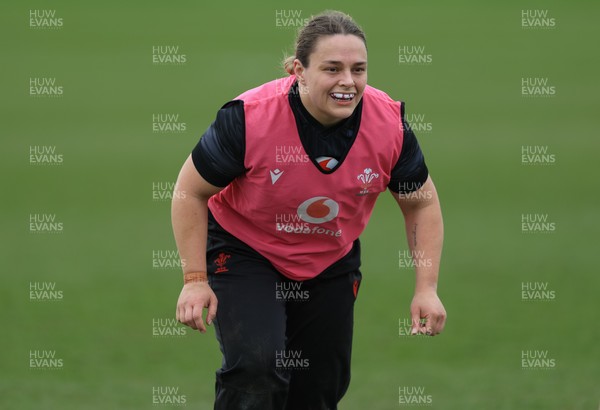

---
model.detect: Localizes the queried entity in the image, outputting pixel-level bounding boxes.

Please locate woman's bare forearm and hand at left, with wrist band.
[171,155,223,333]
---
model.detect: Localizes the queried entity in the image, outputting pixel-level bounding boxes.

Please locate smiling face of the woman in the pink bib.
[294,34,367,126]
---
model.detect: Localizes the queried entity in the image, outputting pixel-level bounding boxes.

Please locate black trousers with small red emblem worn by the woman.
[207,211,361,410]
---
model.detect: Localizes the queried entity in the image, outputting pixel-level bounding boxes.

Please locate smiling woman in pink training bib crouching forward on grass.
[172,7,446,410]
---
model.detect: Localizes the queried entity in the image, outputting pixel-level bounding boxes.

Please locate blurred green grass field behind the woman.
[0,0,600,410]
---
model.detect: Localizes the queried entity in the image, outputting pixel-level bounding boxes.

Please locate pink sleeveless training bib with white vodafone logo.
[208,76,403,280]
